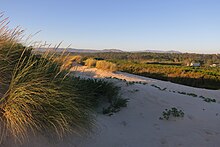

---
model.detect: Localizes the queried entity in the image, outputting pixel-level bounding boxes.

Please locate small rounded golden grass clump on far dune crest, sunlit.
[96,60,117,72]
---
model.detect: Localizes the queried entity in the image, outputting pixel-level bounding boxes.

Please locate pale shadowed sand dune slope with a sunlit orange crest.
[5,67,220,147]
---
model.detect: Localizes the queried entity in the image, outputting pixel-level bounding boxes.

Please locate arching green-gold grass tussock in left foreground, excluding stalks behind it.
[1,53,91,139]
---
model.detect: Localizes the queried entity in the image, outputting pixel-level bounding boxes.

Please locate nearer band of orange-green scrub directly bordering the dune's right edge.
[112,60,220,89]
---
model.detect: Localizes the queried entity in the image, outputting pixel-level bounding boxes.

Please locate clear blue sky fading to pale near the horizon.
[0,0,220,53]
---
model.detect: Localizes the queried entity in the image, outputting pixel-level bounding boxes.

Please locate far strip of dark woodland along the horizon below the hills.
[71,52,220,66]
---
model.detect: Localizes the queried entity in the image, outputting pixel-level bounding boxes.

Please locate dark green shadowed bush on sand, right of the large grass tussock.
[72,77,128,115]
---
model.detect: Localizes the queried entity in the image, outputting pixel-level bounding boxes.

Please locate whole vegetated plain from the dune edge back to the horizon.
[69,52,220,89]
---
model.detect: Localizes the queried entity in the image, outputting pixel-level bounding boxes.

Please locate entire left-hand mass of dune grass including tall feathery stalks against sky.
[0,16,93,142]
